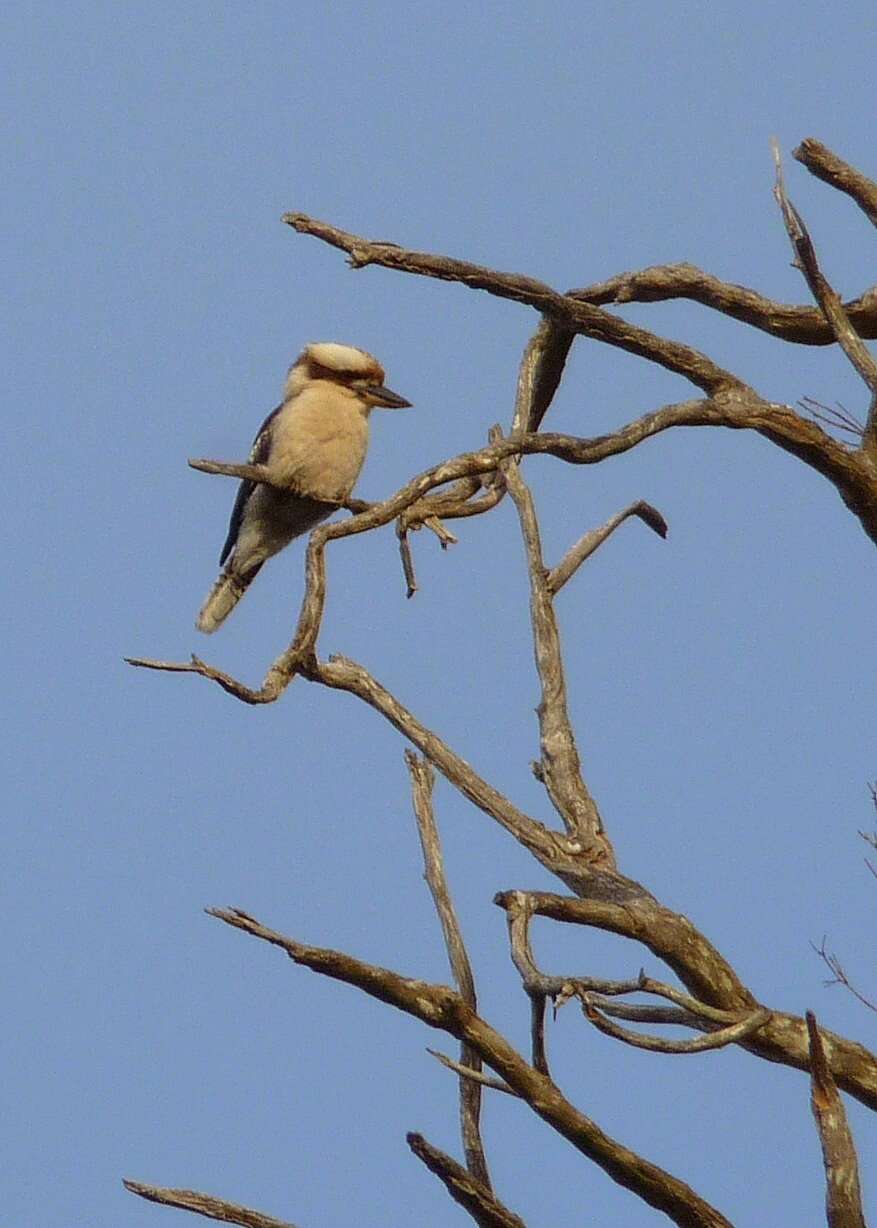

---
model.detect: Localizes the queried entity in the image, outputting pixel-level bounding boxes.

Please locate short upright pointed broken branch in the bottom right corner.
[807,1011,865,1228]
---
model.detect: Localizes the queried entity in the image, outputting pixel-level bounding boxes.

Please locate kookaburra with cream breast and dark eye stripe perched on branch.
[195,341,411,632]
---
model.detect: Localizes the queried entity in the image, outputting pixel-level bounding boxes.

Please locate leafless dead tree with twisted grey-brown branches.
[127,140,877,1228]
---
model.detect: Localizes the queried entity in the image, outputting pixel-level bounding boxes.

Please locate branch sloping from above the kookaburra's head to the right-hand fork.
[283,214,746,395]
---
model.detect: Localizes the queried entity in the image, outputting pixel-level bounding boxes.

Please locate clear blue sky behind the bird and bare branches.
[0,0,877,1228]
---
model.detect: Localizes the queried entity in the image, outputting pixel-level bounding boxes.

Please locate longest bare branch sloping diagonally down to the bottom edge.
[208,909,731,1228]
